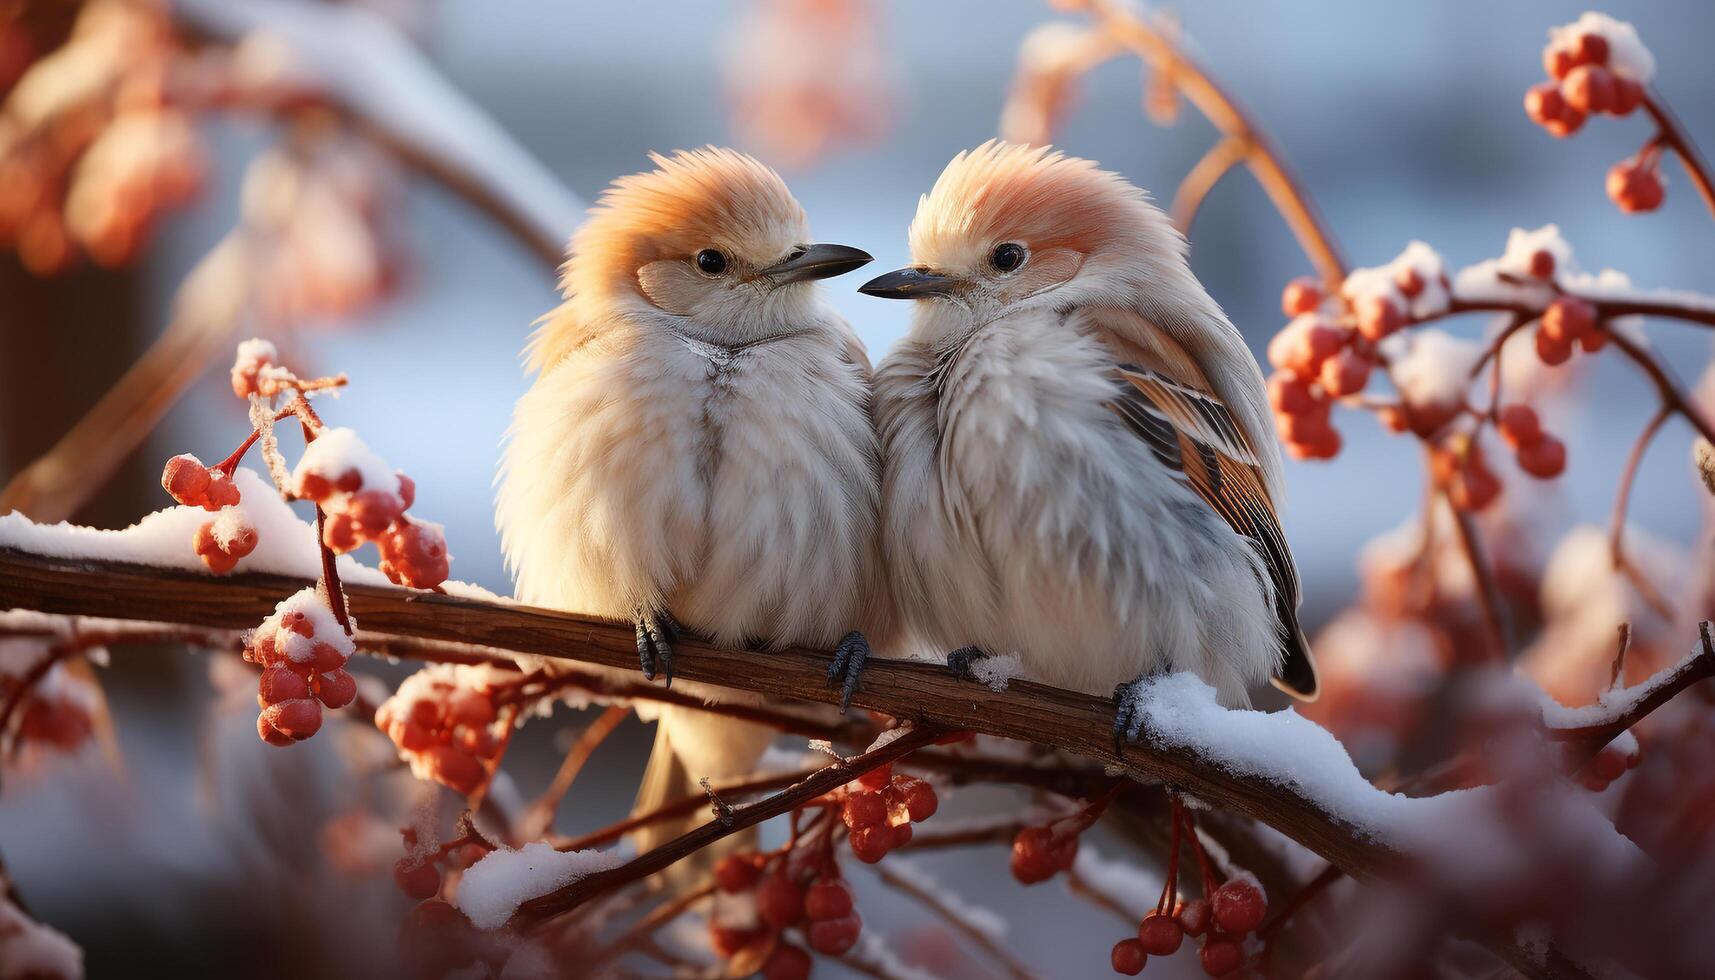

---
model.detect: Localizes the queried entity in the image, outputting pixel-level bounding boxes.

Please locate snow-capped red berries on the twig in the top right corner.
[1525,14,1665,213]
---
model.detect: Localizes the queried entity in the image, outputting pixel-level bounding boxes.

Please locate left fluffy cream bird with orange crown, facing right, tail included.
[497,148,885,850]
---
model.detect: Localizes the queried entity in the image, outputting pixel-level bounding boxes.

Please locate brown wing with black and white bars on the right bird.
[1082,307,1315,697]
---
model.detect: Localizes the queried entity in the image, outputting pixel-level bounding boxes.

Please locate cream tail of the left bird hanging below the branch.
[631,705,779,887]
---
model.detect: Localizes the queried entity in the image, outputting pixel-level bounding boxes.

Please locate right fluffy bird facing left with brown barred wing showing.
[861,141,1317,736]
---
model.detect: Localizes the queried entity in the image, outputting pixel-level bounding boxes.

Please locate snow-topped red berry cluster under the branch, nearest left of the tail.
[376,664,504,796]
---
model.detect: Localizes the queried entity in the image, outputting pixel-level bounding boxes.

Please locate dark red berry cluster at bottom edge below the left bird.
[708,851,863,980]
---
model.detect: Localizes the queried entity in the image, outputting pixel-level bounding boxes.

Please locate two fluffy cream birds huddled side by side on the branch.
[497,142,1315,846]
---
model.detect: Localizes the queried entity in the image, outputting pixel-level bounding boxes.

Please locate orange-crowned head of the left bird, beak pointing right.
[563,148,870,353]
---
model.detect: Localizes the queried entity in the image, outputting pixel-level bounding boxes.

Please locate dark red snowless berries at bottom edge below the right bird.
[1111,875,1267,977]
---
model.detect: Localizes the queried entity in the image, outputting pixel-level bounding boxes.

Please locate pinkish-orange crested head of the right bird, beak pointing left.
[861,141,1185,338]
